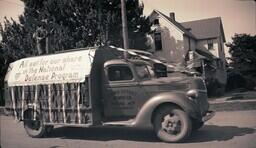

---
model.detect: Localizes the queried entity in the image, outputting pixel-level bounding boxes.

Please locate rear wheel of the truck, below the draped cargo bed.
[24,113,50,138]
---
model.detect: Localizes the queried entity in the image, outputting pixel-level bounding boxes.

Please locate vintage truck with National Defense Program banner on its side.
[5,47,214,142]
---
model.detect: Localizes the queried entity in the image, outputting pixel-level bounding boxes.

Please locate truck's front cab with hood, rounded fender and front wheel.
[99,59,212,142]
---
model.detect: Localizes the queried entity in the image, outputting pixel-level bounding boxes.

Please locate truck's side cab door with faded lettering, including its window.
[103,64,142,118]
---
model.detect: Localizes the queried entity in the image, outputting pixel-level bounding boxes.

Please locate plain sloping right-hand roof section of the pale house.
[181,17,226,42]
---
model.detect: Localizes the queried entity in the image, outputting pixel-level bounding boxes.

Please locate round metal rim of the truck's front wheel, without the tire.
[161,114,182,135]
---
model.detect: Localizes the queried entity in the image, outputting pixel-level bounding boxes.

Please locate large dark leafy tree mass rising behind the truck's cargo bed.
[2,0,150,55]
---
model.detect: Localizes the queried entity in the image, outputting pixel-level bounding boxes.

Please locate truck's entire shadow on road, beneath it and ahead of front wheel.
[48,125,255,143]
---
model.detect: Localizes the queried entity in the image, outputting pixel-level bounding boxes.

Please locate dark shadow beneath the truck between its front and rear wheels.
[48,127,159,142]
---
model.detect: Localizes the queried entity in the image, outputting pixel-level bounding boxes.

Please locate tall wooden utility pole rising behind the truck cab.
[121,0,129,59]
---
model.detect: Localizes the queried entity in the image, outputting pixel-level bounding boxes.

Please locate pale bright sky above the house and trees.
[0,0,256,56]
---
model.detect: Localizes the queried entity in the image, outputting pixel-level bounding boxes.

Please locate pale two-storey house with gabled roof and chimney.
[149,10,227,96]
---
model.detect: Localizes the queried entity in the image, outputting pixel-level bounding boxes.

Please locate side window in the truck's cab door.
[108,66,133,81]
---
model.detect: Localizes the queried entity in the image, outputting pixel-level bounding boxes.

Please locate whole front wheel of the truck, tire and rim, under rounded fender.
[153,106,192,142]
